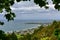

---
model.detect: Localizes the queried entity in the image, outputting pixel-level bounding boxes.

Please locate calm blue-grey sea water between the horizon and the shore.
[0,20,52,32]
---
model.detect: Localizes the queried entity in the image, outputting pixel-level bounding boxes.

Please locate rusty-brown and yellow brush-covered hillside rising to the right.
[32,21,60,40]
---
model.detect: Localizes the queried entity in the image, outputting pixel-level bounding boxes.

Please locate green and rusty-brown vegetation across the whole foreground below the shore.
[0,21,60,40]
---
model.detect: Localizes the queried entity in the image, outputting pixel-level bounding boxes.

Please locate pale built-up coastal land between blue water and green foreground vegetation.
[6,24,48,34]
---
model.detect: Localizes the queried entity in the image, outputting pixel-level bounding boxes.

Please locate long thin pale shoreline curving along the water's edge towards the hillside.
[4,23,51,34]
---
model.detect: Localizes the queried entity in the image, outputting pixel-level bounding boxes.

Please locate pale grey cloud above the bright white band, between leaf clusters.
[13,1,35,8]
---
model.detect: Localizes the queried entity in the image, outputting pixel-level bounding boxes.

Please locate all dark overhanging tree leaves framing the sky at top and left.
[0,0,60,25]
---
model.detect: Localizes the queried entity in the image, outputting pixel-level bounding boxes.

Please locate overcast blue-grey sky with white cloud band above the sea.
[0,0,60,20]
